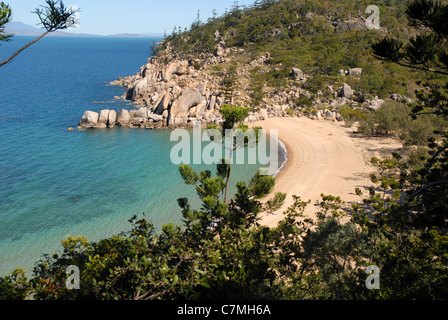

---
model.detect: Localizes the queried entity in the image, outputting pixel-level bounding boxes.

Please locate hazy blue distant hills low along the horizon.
[6,21,163,38]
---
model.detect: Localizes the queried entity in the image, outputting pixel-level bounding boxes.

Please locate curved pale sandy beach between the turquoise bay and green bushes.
[253,117,402,227]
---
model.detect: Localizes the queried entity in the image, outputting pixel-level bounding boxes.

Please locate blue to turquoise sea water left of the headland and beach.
[0,36,259,276]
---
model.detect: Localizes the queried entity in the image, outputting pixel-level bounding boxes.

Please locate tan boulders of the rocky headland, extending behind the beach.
[78,15,405,129]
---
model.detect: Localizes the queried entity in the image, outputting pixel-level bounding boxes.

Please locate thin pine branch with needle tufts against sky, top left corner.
[0,0,79,67]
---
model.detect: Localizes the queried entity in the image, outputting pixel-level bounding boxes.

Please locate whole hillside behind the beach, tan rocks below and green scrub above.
[108,0,448,130]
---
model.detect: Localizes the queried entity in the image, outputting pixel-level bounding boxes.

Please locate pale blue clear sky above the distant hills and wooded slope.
[4,0,260,35]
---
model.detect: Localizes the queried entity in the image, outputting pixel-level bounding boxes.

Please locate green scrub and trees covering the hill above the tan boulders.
[158,0,444,102]
